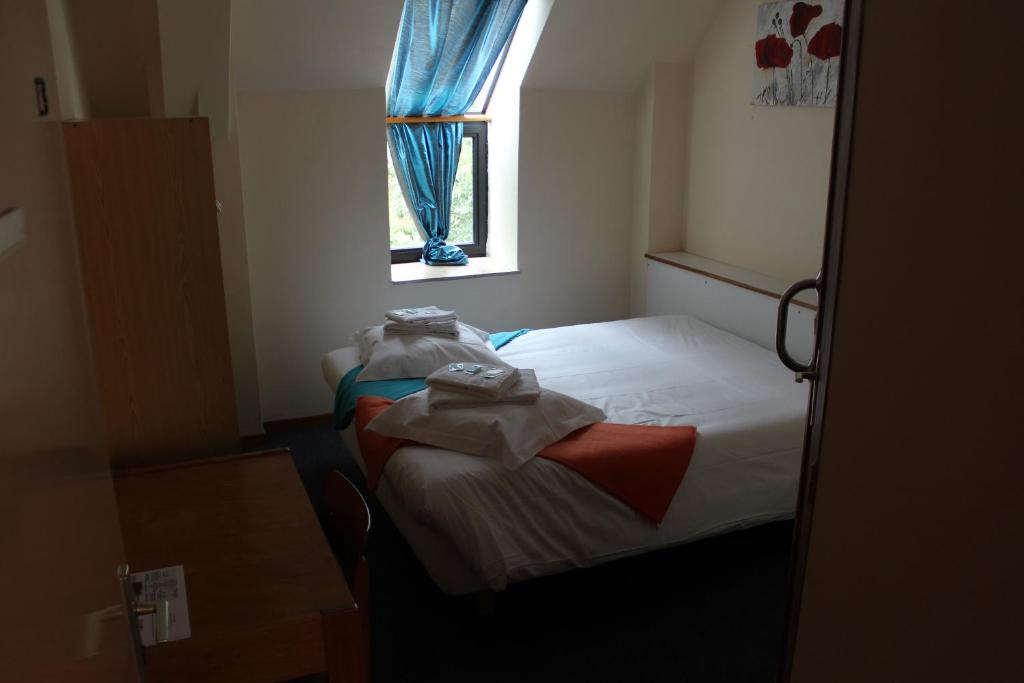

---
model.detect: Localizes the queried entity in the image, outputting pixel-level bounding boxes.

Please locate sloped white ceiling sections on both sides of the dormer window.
[231,0,720,92]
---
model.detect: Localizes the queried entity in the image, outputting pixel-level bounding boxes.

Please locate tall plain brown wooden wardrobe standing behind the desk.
[63,118,239,465]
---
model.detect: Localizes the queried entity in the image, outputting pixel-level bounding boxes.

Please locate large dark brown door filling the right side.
[784,0,1024,683]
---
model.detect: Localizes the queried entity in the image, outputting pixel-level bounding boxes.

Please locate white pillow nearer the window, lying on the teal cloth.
[352,323,508,382]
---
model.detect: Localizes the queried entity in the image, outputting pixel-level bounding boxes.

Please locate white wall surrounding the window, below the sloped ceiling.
[238,88,634,420]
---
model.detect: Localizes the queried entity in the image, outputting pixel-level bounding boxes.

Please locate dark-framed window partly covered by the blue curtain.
[385,122,487,263]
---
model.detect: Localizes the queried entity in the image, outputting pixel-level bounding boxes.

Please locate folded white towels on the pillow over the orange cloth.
[426,362,541,410]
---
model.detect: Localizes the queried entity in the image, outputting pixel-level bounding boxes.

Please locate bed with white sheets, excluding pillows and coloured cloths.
[323,315,807,595]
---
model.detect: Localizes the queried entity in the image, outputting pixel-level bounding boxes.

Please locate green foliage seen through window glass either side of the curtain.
[385,137,473,249]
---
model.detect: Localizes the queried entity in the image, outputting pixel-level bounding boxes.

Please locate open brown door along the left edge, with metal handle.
[0,0,138,683]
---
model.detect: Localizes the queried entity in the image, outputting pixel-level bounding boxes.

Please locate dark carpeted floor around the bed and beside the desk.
[267,426,793,683]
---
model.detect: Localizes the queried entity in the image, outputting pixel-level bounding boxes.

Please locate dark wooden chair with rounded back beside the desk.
[324,470,370,681]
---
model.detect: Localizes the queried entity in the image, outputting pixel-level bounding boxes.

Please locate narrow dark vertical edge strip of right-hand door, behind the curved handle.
[779,0,864,682]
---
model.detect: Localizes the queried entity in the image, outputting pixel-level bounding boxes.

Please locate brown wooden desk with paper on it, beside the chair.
[114,449,367,683]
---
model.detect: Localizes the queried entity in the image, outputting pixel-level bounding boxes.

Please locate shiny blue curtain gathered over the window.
[387,0,526,265]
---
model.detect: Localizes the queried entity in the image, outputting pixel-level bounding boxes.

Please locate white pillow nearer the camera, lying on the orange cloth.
[367,388,606,470]
